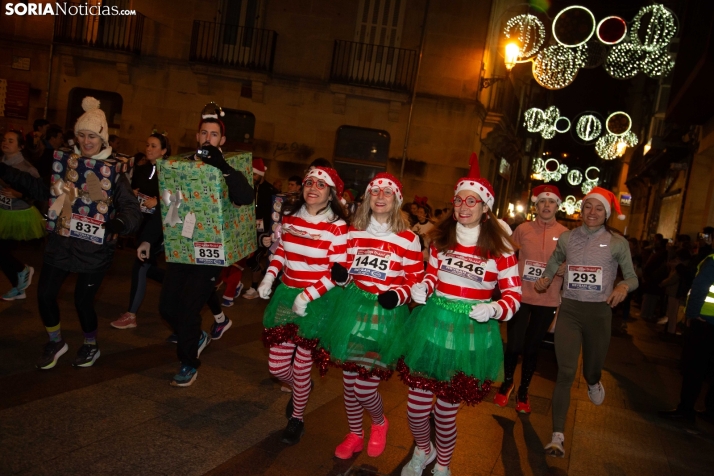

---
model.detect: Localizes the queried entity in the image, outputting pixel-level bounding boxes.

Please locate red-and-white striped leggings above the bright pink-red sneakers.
[342,371,384,436]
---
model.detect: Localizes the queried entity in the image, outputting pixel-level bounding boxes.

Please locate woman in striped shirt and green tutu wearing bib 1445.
[318,173,424,459]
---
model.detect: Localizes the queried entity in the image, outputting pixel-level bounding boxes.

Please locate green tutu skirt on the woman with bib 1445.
[316,283,409,380]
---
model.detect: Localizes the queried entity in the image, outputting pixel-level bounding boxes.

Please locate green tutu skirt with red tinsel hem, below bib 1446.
[384,296,503,404]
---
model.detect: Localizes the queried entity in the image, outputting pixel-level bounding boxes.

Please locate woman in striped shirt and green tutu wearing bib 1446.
[385,154,521,476]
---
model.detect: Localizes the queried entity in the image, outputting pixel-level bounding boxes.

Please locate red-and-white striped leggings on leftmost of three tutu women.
[268,342,312,420]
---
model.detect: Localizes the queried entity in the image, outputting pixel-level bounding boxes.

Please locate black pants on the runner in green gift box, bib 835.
[159,263,223,368]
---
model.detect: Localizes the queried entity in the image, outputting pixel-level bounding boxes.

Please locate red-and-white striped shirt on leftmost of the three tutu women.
[266,207,347,301]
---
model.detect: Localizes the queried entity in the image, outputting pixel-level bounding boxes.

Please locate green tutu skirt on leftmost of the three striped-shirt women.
[263,283,343,350]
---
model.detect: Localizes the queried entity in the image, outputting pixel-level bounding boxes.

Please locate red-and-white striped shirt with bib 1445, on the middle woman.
[347,227,424,305]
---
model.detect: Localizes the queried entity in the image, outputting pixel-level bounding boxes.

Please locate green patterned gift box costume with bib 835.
[156,152,256,267]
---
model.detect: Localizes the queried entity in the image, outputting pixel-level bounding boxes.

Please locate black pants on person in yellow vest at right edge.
[679,319,714,413]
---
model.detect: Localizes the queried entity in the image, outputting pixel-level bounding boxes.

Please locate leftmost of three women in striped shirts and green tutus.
[258,167,347,444]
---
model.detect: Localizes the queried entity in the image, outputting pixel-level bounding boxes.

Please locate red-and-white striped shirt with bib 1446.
[424,243,521,321]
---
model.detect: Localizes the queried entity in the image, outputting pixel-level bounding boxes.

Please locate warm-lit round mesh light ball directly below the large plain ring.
[533,45,588,89]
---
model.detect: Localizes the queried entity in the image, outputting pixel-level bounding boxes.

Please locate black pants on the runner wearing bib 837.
[37,263,106,333]
